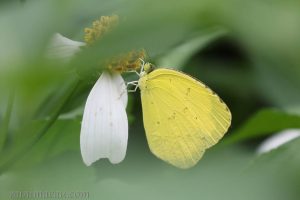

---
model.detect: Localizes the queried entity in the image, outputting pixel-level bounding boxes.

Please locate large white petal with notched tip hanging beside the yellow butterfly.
[80,72,128,166]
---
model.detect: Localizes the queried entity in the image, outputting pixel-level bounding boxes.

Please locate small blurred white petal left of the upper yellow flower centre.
[47,33,85,61]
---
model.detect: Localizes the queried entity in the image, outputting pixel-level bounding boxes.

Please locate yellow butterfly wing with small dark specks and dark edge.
[139,69,231,168]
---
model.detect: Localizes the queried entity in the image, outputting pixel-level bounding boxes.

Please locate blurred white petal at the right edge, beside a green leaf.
[257,129,300,154]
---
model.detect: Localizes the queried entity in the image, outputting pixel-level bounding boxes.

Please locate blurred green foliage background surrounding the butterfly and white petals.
[0,0,300,200]
